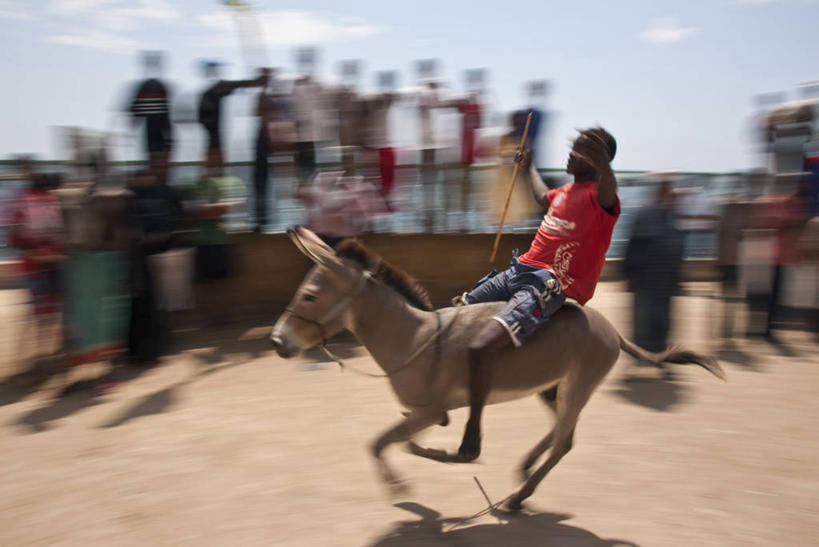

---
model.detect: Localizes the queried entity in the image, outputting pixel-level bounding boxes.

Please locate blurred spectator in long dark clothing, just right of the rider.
[623,179,684,372]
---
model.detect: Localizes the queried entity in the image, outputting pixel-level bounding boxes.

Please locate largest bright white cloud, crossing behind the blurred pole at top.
[195,10,384,47]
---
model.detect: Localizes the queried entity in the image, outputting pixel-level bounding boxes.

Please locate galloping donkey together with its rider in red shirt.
[271,117,723,509]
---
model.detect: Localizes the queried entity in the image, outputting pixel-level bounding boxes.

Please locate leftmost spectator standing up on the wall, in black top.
[128,51,173,163]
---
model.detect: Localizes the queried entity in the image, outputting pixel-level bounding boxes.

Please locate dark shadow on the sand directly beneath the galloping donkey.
[371,502,636,547]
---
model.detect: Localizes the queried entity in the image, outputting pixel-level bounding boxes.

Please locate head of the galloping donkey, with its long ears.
[270,226,370,358]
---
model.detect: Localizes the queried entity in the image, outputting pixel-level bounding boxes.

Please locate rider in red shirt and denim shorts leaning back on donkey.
[453,127,620,461]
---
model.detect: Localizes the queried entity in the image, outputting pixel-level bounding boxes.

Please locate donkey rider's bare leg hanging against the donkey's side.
[458,321,511,461]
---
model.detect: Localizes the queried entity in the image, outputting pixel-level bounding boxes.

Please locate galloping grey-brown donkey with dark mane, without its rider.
[270,227,725,510]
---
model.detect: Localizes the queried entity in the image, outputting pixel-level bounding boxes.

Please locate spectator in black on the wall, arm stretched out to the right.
[199,61,269,174]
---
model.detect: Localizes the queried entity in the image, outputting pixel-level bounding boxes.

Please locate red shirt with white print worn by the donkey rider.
[519,181,620,304]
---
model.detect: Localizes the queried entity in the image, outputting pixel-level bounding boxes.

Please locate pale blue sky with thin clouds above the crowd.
[0,0,819,171]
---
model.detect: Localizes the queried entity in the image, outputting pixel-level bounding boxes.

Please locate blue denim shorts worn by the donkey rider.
[463,258,566,346]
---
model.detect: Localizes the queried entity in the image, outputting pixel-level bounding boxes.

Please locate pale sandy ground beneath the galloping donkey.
[0,284,819,546]
